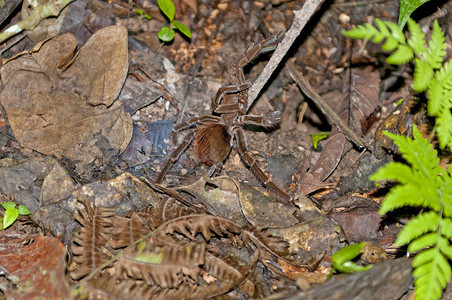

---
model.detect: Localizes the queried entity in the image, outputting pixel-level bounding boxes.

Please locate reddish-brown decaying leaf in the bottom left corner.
[0,231,69,299]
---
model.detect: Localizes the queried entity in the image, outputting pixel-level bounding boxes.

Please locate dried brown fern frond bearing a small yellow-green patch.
[115,239,206,288]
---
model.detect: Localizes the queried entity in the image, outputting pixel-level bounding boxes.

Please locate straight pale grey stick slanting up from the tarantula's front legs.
[247,0,322,111]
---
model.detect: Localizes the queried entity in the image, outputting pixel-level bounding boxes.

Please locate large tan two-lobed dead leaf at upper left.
[0,26,132,177]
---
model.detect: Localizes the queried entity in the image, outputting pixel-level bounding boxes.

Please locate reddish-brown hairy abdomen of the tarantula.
[195,124,232,166]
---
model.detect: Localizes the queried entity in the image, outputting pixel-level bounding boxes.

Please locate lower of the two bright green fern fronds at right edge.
[370,125,452,299]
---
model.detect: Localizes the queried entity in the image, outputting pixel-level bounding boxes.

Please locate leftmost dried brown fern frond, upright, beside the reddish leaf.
[71,200,115,279]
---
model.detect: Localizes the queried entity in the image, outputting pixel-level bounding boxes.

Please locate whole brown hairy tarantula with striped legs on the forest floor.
[156,32,292,202]
